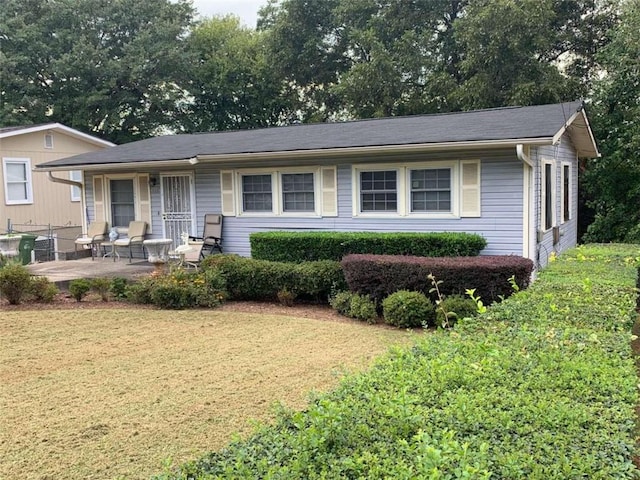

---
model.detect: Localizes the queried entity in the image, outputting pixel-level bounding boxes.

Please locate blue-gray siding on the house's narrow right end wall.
[532,134,578,267]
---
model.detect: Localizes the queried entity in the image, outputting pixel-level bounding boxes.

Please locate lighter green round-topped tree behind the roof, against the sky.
[181,16,292,132]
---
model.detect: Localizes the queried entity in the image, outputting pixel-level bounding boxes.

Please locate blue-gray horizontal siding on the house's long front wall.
[86,150,523,256]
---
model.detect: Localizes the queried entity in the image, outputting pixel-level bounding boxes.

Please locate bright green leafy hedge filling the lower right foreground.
[158,246,639,480]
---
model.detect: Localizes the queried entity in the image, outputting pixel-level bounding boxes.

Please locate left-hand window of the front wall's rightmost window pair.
[360,170,398,212]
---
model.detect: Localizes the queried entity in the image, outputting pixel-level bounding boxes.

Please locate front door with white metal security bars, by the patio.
[160,173,196,248]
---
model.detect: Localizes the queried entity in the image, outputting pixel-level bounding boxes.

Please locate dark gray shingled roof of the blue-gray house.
[36,101,582,169]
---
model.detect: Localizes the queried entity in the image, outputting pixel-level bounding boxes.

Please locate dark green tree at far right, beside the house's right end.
[583,1,640,243]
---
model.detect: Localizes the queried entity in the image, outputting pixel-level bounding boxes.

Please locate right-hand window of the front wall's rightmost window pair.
[410,168,451,212]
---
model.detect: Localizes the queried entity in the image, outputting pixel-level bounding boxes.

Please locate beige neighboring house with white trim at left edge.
[0,123,114,233]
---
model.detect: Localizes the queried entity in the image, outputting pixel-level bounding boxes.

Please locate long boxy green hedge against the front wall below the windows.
[249,232,487,262]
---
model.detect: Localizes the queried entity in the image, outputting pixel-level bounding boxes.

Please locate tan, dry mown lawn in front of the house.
[0,309,413,480]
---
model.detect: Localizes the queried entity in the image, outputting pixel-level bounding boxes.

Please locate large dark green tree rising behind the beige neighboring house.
[0,0,193,143]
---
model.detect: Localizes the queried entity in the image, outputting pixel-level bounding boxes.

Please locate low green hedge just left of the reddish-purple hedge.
[202,255,346,302]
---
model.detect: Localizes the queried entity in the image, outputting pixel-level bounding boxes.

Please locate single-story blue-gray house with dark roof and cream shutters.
[36,102,599,264]
